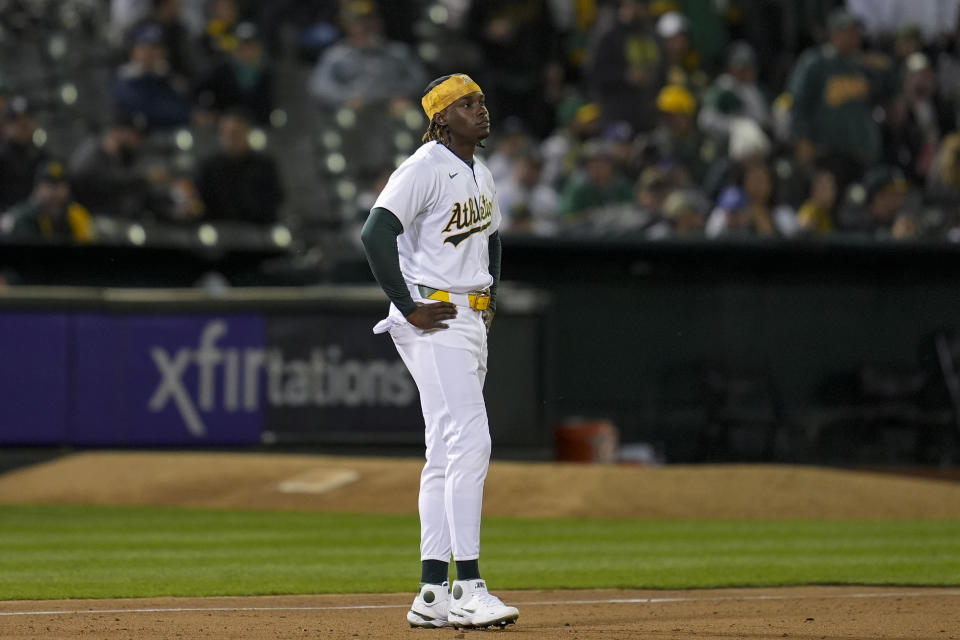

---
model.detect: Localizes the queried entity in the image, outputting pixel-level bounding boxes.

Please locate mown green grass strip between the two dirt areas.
[0,505,960,600]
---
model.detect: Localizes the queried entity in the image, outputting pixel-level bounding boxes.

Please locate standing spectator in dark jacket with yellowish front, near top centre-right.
[585,0,663,131]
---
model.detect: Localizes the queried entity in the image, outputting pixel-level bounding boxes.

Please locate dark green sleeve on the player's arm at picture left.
[360,207,417,316]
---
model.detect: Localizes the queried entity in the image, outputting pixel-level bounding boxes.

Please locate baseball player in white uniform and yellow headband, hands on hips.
[361,74,520,628]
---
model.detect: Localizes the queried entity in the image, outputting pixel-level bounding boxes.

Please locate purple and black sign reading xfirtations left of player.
[60,314,423,445]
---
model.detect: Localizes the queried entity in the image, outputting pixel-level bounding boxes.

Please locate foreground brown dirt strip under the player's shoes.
[0,587,960,640]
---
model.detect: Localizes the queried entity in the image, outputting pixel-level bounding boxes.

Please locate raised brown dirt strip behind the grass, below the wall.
[0,452,960,519]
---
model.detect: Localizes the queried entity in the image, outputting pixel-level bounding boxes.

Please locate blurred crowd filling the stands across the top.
[0,0,960,252]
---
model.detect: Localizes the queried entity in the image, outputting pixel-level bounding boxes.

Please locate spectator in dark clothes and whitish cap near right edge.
[885,53,955,183]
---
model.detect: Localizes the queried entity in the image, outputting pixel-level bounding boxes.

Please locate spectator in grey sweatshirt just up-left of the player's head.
[310,0,429,109]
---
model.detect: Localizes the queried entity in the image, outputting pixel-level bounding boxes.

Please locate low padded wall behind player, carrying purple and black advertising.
[0,287,550,446]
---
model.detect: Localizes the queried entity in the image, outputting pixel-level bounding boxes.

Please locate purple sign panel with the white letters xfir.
[73,315,265,445]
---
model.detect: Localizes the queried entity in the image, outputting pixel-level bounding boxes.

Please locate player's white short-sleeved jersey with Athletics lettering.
[373,142,501,293]
